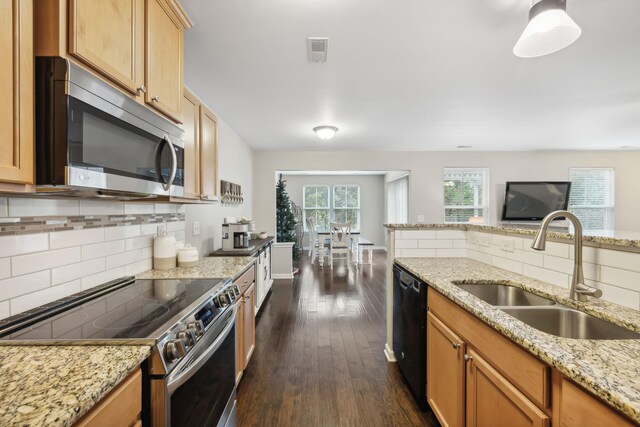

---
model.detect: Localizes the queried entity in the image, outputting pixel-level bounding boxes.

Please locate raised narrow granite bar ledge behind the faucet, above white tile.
[384,223,640,251]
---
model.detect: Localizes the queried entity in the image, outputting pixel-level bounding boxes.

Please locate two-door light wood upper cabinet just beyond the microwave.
[174,87,219,203]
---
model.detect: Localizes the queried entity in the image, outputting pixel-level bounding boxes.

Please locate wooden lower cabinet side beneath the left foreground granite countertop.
[74,369,142,427]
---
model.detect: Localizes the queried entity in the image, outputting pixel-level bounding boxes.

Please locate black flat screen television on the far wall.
[502,181,571,221]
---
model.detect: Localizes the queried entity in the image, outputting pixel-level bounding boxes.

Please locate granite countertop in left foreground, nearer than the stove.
[0,346,151,426]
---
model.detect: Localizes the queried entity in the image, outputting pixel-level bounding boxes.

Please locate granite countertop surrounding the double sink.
[395,258,640,422]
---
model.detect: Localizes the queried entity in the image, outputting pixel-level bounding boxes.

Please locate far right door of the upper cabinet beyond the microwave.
[200,105,218,200]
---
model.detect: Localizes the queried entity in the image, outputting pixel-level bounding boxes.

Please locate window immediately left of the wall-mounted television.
[444,168,489,223]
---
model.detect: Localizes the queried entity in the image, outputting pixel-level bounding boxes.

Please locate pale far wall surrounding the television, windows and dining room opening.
[253,151,640,232]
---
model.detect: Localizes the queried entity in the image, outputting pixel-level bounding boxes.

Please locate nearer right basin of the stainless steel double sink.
[501,305,640,340]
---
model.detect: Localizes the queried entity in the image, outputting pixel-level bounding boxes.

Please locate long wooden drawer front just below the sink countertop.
[428,288,551,408]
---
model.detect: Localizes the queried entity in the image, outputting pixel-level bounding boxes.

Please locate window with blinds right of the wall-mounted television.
[569,168,614,230]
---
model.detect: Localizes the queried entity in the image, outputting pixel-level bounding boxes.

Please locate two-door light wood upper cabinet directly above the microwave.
[35,0,192,122]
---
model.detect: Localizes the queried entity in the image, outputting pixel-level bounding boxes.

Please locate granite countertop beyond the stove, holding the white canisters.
[136,257,256,279]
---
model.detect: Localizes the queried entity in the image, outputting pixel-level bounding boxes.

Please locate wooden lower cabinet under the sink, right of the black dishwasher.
[427,288,634,427]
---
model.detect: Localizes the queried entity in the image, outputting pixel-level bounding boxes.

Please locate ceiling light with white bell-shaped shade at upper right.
[513,0,582,58]
